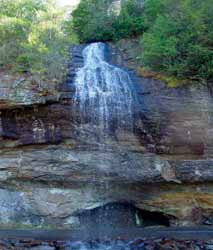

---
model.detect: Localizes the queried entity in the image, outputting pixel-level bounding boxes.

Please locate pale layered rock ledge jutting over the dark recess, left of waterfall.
[0,70,58,110]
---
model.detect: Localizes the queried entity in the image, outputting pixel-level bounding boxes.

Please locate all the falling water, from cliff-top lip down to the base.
[70,42,140,250]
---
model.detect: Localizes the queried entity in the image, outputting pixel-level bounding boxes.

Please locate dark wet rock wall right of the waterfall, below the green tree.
[109,39,213,158]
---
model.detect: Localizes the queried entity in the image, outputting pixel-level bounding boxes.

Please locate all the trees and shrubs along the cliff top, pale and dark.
[0,0,213,84]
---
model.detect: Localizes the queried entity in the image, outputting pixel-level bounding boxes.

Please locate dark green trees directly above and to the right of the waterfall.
[70,0,213,81]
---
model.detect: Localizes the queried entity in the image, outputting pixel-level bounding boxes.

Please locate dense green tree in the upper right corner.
[142,0,213,80]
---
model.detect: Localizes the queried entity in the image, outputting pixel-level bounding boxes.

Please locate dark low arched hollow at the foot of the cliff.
[78,202,171,228]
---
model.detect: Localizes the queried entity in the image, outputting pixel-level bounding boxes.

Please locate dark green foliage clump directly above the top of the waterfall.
[70,0,144,42]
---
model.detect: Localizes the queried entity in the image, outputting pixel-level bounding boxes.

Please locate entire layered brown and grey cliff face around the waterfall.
[0,39,213,228]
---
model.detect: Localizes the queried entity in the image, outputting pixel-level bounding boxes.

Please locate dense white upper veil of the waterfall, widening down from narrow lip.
[74,42,133,142]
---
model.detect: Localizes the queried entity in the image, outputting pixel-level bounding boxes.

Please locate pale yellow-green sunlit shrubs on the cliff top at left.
[0,0,75,80]
